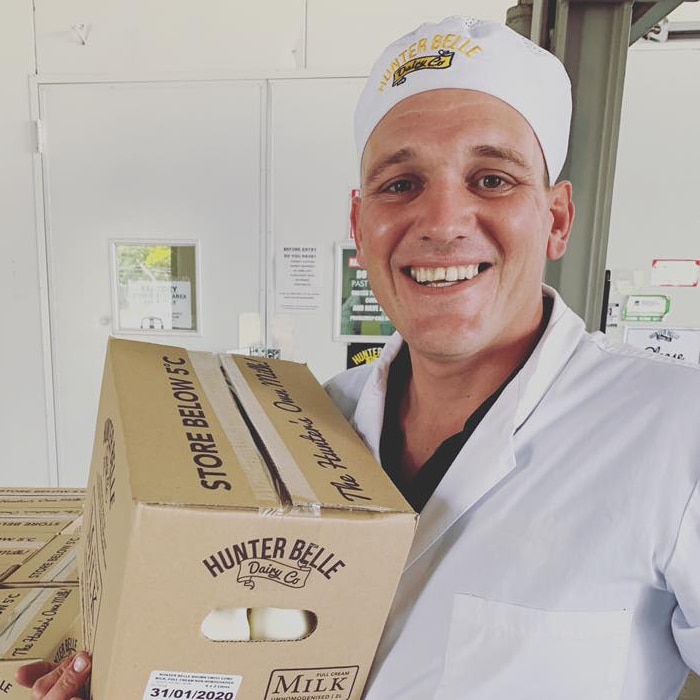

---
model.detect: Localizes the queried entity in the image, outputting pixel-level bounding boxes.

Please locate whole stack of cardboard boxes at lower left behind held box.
[0,488,85,700]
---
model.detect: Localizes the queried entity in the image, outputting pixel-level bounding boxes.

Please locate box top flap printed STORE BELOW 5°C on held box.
[108,338,280,510]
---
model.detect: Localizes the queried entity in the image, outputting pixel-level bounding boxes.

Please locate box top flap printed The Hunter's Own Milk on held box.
[221,355,413,513]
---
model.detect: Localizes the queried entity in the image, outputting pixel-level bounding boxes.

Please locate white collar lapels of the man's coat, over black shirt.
[354,285,584,568]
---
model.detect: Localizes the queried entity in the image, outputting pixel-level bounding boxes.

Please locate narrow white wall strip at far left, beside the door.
[0,0,54,485]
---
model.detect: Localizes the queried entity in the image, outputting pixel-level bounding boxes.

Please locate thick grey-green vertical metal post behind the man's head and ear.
[546,0,633,330]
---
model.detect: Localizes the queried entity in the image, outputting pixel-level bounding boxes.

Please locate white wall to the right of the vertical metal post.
[606,3,700,339]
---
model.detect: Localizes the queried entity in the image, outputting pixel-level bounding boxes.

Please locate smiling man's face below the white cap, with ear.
[353,90,573,360]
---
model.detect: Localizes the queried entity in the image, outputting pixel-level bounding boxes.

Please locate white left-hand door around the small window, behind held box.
[39,81,265,486]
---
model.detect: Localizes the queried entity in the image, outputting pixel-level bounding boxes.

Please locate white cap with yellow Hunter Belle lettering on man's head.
[355,17,571,184]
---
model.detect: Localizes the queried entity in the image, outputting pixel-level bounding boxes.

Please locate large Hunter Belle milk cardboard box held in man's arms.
[81,339,417,700]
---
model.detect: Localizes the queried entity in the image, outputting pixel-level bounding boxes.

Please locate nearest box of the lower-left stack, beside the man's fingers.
[0,587,82,700]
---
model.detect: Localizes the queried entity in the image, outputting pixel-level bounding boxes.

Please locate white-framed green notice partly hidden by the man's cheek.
[335,243,395,342]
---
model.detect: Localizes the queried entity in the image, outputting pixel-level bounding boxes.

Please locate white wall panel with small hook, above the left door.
[35,0,304,75]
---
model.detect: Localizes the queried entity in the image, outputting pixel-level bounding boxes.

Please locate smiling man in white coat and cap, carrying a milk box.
[23,18,700,700]
